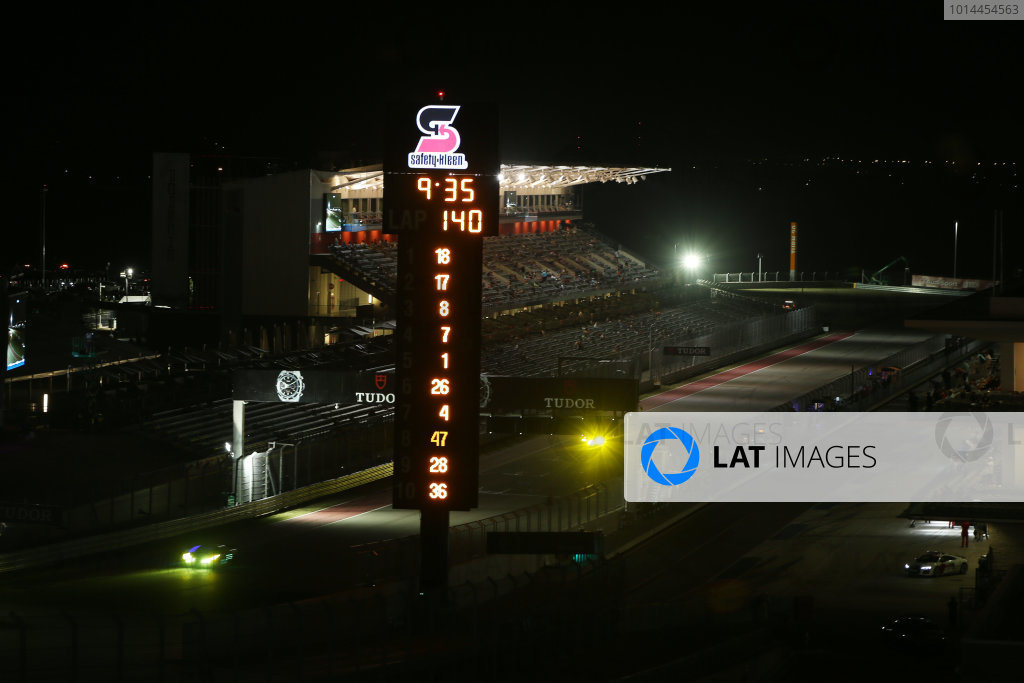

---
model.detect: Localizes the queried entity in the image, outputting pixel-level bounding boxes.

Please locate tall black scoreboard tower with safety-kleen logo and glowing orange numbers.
[384,102,500,510]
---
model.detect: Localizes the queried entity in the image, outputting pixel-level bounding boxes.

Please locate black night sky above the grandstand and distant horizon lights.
[2,3,1024,276]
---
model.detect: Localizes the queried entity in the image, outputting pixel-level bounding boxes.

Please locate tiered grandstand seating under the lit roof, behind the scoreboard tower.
[321,216,790,376]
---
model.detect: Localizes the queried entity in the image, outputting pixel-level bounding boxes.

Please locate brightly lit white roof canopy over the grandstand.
[317,164,672,191]
